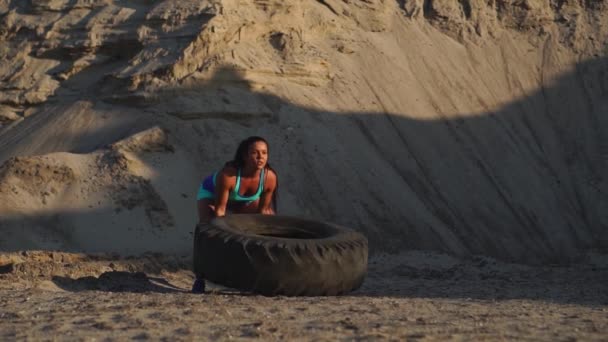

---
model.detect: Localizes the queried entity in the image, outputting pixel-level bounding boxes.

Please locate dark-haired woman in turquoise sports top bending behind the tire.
[192,136,278,293]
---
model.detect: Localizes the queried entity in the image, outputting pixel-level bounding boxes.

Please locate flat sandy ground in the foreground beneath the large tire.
[0,252,608,341]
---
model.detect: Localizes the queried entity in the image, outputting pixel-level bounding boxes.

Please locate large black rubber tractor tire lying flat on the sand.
[193,214,368,296]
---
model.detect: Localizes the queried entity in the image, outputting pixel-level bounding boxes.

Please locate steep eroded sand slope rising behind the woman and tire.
[0,0,608,263]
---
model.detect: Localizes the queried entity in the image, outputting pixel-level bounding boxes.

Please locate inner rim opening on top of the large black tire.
[222,215,335,239]
